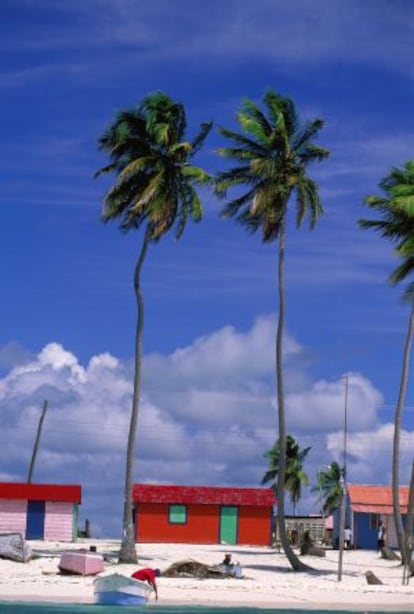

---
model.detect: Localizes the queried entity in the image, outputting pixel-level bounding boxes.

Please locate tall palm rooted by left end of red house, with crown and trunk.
[96,92,211,563]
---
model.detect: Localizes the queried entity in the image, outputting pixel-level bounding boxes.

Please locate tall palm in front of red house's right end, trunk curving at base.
[216,90,329,570]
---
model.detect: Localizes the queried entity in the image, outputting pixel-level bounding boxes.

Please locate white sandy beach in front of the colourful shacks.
[0,540,414,612]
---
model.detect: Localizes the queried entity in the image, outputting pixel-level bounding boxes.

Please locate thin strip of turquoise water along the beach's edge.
[0,602,409,614]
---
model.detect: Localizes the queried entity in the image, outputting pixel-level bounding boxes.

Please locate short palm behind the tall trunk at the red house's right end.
[262,435,311,514]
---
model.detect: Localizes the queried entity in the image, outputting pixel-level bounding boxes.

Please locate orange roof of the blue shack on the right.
[347,484,408,514]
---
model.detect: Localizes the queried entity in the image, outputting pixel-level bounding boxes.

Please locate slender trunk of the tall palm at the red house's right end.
[276,223,310,571]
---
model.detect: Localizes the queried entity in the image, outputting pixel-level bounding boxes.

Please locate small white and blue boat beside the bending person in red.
[93,573,152,605]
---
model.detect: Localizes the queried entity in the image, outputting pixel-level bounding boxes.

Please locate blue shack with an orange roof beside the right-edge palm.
[334,484,408,550]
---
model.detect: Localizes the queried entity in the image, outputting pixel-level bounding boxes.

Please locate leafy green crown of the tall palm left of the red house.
[96,92,212,241]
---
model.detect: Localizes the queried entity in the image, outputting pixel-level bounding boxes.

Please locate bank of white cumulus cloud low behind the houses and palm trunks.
[0,316,408,536]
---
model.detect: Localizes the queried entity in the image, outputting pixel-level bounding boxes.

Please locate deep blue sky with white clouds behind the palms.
[0,0,414,536]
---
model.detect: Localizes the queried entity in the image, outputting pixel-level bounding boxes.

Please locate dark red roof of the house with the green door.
[132,484,276,507]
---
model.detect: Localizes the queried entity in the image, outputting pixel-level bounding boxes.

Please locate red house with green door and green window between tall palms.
[133,484,276,546]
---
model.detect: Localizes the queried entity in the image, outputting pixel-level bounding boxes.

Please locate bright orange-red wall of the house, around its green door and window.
[136,503,271,546]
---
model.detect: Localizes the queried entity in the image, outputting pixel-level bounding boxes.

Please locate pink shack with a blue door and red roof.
[0,482,81,541]
